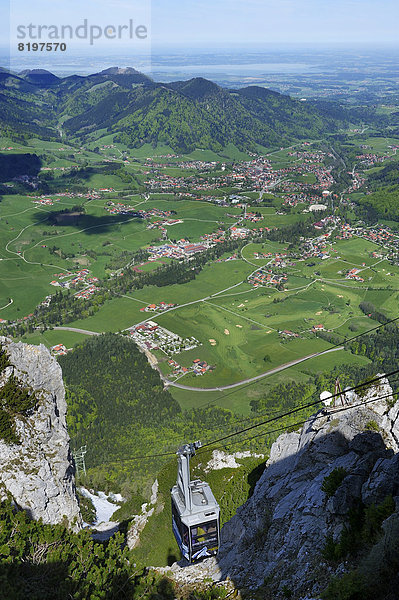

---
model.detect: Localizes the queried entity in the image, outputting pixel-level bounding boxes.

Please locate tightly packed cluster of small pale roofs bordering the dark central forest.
[128,321,200,356]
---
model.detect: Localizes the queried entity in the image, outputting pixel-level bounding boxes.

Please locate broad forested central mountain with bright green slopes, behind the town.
[60,74,350,151]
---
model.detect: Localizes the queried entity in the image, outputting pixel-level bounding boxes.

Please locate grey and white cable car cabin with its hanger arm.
[171,442,220,563]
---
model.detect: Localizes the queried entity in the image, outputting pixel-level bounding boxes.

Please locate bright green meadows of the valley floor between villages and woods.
[0,130,399,414]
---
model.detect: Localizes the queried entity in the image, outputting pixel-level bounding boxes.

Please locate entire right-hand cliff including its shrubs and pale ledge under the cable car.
[162,380,399,600]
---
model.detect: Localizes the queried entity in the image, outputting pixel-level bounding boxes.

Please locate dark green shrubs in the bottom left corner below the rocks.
[0,502,225,600]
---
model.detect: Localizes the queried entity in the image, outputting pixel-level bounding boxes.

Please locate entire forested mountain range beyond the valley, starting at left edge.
[0,67,362,152]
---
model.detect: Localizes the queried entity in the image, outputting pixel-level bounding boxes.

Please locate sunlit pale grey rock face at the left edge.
[0,337,82,529]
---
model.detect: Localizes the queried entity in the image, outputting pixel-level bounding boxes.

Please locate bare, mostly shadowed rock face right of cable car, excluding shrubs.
[218,380,399,599]
